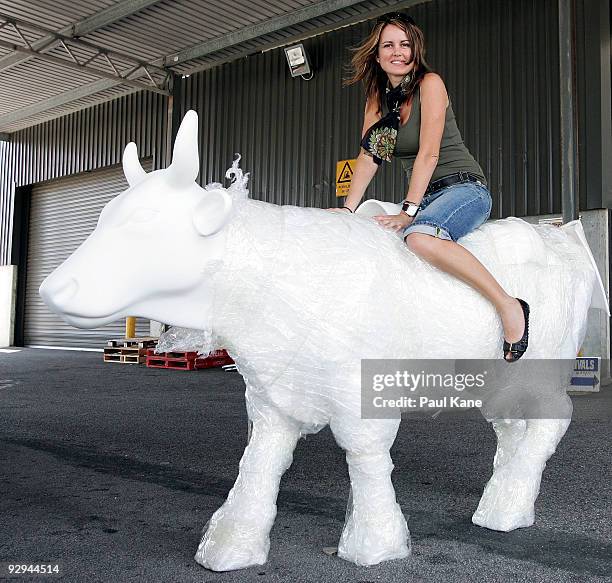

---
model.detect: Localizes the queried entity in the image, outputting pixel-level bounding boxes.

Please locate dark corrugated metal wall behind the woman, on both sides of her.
[182,0,561,217]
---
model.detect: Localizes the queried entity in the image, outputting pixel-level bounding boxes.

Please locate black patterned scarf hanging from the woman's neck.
[361,71,412,166]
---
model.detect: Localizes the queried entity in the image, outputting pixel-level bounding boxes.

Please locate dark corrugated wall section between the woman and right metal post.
[414,0,561,217]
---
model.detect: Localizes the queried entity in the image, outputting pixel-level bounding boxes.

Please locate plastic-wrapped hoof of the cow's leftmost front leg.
[195,518,270,571]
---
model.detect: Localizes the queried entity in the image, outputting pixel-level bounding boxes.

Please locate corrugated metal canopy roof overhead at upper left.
[0,0,414,132]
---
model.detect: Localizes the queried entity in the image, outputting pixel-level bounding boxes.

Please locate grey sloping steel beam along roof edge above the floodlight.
[164,0,366,67]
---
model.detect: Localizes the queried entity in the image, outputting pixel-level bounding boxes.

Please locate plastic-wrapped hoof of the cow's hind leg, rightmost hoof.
[472,462,543,532]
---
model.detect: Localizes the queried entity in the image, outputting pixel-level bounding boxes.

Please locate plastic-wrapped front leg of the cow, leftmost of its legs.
[195,415,300,571]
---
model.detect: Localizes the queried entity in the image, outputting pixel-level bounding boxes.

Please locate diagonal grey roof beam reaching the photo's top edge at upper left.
[0,0,160,71]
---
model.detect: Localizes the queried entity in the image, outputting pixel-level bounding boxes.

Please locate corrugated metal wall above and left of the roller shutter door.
[0,92,167,265]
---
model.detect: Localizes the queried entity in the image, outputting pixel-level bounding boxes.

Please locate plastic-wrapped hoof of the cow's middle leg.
[338,505,410,566]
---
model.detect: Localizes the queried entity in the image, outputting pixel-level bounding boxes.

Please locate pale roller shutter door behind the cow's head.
[24,160,151,348]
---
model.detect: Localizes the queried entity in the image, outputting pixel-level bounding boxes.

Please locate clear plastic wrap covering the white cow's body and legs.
[178,196,596,570]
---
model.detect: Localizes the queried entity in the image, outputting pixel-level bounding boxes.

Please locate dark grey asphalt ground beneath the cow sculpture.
[0,349,612,583]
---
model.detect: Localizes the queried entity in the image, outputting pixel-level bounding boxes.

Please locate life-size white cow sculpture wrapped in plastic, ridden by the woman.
[40,111,607,571]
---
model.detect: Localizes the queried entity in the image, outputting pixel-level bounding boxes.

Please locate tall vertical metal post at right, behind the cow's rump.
[559,0,578,223]
